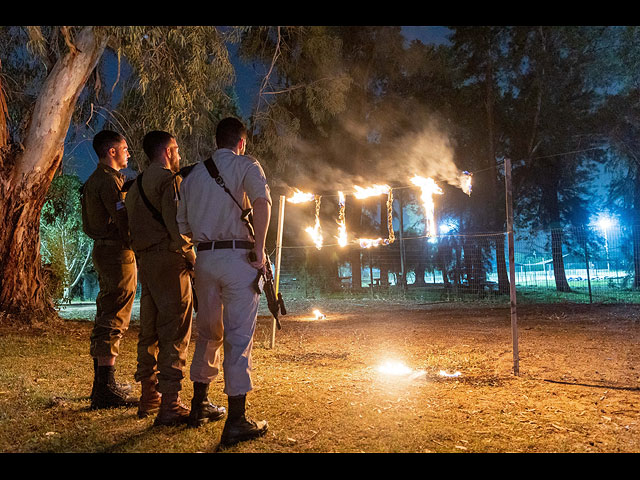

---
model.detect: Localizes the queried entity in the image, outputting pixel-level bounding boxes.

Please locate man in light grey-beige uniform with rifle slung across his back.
[178,118,271,447]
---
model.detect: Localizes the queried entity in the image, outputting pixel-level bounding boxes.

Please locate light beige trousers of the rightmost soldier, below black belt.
[190,249,260,396]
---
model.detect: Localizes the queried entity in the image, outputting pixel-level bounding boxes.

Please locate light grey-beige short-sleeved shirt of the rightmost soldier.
[177,148,271,244]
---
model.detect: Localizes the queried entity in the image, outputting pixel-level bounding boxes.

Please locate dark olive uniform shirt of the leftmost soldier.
[82,163,130,248]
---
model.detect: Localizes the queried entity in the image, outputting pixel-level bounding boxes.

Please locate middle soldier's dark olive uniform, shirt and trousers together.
[125,163,195,394]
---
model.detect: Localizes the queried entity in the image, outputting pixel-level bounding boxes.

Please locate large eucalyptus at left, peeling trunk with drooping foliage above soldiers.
[0,26,231,316]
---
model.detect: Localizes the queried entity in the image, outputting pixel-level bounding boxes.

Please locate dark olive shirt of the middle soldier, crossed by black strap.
[125,163,193,260]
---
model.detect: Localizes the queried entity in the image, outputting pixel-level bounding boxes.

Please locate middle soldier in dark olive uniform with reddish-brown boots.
[125,131,225,426]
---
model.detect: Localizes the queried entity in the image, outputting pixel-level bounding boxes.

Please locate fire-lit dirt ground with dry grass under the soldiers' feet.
[0,301,640,453]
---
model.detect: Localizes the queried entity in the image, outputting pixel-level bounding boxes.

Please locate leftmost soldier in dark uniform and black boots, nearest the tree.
[82,130,138,409]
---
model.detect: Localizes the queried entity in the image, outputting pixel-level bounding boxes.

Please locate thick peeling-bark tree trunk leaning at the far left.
[0,27,107,315]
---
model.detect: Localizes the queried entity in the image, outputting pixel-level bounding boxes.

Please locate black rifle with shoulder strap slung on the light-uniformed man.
[204,157,287,330]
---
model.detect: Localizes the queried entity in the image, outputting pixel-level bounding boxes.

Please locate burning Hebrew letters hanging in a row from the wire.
[287,172,472,250]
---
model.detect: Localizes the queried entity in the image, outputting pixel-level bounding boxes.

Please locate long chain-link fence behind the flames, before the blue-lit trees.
[272,227,640,304]
